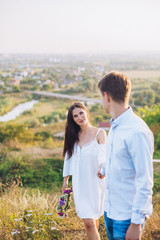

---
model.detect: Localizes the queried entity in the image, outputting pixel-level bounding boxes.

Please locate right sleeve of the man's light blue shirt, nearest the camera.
[129,130,154,224]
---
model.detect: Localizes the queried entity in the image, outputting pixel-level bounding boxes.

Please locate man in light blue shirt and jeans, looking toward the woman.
[98,72,154,240]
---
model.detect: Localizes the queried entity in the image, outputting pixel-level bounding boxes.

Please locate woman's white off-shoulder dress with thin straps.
[63,129,106,219]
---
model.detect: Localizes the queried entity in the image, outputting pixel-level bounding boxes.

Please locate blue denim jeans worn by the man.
[104,212,145,240]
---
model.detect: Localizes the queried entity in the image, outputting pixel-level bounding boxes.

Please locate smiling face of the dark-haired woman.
[72,108,88,126]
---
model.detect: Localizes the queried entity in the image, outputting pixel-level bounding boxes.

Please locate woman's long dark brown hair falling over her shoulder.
[63,102,89,158]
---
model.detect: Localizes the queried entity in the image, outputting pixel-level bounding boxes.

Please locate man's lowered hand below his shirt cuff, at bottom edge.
[125,223,141,240]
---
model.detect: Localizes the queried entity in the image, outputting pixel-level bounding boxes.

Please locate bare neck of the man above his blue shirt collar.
[110,102,129,120]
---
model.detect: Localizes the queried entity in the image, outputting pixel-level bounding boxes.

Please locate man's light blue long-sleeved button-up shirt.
[101,107,154,224]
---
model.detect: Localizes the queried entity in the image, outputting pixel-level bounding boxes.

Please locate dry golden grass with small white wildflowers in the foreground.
[0,179,160,240]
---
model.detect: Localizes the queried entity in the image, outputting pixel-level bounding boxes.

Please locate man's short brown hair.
[98,72,131,103]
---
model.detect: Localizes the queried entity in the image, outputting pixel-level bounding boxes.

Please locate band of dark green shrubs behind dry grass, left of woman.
[0,157,63,189]
